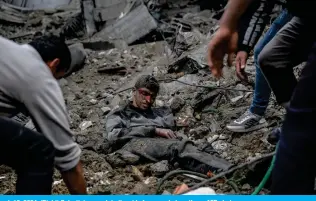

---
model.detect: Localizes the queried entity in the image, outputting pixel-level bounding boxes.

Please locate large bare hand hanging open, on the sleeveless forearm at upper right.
[207,28,238,78]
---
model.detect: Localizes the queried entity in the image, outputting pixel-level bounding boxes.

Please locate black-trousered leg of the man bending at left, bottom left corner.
[0,118,55,195]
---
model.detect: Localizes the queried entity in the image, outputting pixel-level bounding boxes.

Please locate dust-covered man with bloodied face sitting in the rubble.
[104,75,231,173]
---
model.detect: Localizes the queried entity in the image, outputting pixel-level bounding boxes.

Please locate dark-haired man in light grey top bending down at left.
[0,36,86,195]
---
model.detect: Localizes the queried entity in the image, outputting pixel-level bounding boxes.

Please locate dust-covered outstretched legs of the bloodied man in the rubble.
[121,138,231,172]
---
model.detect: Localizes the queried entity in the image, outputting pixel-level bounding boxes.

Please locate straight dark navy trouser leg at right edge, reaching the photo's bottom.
[271,41,316,194]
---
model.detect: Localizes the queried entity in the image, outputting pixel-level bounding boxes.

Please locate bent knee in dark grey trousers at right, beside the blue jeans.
[259,17,315,105]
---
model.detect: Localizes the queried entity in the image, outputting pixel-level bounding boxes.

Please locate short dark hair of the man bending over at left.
[29,35,71,72]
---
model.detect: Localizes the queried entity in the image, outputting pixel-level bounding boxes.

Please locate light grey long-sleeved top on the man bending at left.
[0,37,81,171]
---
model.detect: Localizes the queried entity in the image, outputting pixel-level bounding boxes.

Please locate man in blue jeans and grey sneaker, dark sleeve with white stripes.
[226,0,292,133]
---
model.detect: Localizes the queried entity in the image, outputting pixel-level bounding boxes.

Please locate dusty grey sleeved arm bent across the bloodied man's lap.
[104,112,155,142]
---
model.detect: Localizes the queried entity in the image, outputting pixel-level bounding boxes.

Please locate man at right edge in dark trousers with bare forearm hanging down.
[208,0,316,194]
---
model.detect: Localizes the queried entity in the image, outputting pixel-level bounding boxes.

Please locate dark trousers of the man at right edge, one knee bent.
[259,17,316,195]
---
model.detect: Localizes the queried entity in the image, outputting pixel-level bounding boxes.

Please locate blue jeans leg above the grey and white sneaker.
[250,9,292,116]
